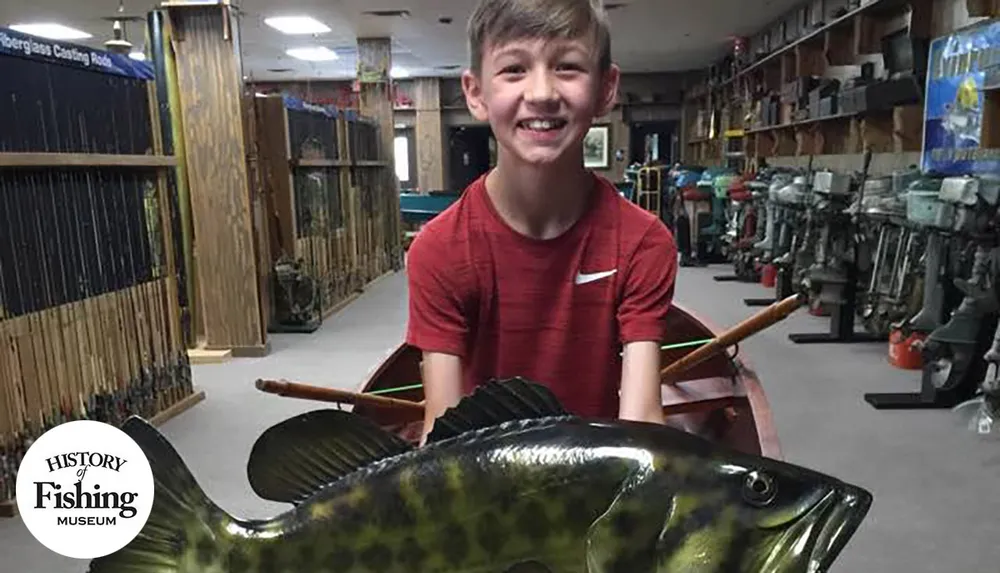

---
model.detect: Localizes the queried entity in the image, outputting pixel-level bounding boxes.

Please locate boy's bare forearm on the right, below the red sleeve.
[618,341,664,424]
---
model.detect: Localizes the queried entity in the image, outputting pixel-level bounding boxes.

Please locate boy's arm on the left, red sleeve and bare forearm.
[406,228,468,444]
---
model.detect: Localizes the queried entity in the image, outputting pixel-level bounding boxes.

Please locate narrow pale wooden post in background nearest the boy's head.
[414,78,444,191]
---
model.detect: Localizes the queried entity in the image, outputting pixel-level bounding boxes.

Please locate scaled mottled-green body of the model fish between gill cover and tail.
[210,420,638,573]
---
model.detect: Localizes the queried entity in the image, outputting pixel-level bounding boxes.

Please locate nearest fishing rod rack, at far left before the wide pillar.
[0,24,204,517]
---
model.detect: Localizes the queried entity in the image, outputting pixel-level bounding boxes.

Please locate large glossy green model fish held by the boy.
[90,379,872,573]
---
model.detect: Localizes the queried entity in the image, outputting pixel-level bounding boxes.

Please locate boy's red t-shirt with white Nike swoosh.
[406,175,677,418]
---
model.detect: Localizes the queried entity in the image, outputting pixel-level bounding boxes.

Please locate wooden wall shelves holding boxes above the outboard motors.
[685,0,933,165]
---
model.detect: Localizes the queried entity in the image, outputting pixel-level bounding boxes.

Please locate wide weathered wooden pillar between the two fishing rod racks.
[169,6,265,355]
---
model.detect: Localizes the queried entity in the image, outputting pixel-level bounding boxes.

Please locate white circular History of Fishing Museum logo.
[17,420,153,559]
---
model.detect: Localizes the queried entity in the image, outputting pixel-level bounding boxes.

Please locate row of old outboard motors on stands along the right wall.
[704,149,1000,431]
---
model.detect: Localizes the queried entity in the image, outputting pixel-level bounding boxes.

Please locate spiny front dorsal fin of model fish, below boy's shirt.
[427,377,568,443]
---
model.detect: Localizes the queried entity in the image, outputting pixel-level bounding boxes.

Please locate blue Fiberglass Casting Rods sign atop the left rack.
[0,28,155,80]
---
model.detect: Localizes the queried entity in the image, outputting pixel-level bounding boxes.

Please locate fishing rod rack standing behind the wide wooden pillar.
[254,94,402,332]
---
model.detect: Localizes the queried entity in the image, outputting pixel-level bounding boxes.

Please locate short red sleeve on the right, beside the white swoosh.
[618,221,677,344]
